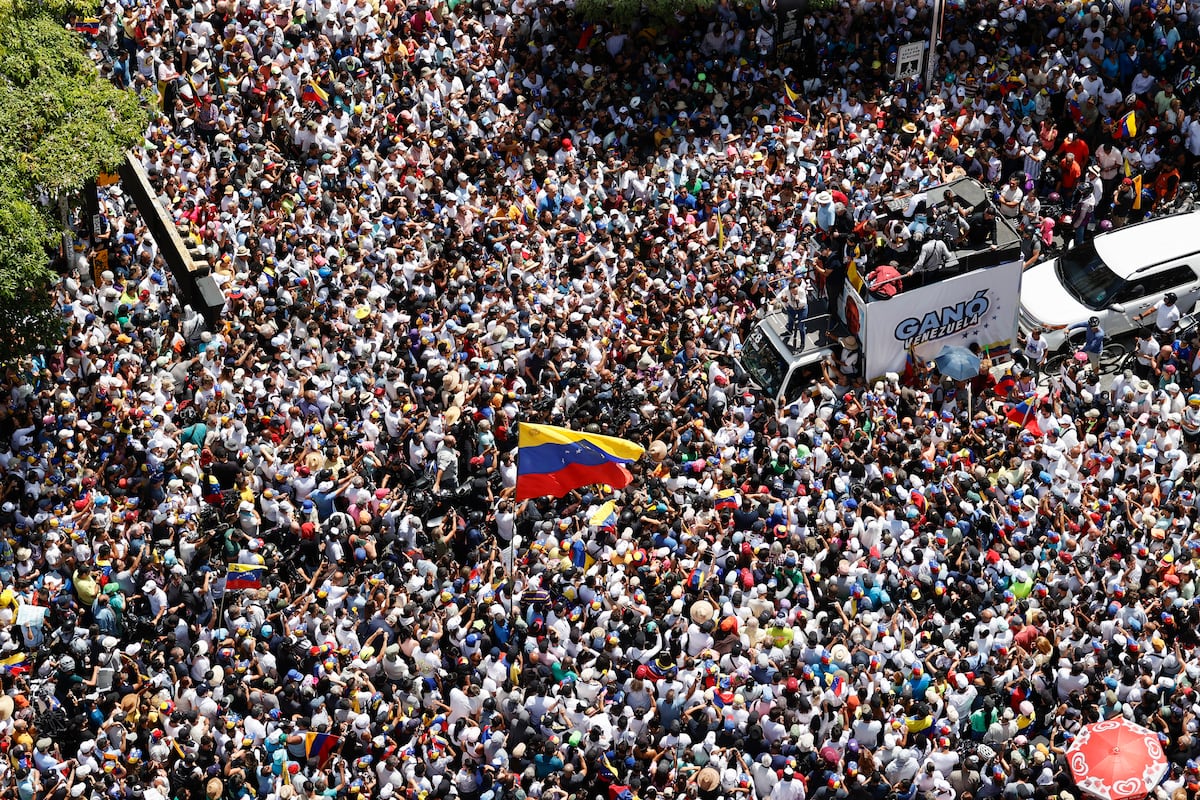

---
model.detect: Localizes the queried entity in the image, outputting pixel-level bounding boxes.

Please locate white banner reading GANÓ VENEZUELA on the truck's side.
[863,260,1021,379]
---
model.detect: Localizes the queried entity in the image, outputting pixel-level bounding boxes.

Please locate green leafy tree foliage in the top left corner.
[0,0,149,362]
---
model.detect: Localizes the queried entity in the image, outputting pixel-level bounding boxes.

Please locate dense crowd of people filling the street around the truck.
[0,0,1200,800]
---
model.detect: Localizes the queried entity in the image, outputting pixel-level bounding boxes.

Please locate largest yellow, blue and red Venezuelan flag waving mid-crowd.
[517,422,646,500]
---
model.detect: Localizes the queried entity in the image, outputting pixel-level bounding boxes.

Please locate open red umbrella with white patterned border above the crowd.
[1067,717,1168,800]
